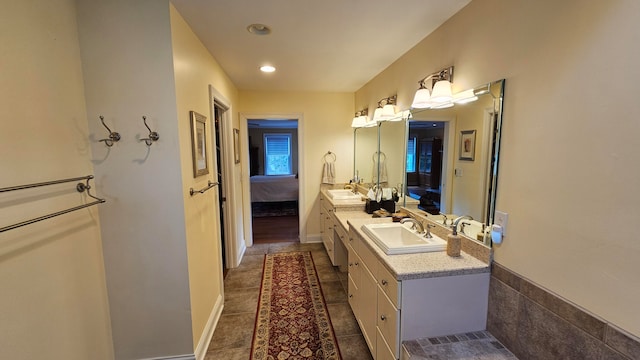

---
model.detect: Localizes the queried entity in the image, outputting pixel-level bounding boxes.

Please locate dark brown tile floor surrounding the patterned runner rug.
[205,242,372,360]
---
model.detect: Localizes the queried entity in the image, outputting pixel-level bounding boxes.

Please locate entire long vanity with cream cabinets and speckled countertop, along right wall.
[321,190,490,360]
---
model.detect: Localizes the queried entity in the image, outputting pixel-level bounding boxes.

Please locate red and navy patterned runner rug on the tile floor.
[251,252,341,360]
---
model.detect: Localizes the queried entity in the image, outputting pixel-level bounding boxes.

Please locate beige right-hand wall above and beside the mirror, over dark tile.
[356,0,640,335]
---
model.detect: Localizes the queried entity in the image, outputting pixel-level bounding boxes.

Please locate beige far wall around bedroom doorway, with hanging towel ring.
[238,91,354,242]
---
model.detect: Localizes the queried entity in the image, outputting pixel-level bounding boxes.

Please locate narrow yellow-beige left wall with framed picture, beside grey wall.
[171,6,241,350]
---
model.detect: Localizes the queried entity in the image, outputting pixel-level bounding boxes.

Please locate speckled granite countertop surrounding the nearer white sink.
[344,212,490,280]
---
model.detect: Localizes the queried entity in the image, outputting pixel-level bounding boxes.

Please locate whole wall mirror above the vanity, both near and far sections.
[354,80,504,245]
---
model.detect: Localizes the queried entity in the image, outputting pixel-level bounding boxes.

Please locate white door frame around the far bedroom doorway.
[239,113,307,246]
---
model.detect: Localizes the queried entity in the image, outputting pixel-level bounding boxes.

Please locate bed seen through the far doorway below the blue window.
[249,175,298,202]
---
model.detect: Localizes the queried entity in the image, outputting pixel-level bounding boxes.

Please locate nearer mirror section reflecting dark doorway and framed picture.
[406,80,504,245]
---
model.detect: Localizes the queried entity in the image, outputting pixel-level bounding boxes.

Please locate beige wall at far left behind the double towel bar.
[0,0,114,360]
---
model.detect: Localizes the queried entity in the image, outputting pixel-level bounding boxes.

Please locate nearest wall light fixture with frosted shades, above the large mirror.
[411,66,453,109]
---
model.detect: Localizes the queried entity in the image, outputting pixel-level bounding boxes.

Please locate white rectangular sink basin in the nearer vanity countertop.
[361,223,447,255]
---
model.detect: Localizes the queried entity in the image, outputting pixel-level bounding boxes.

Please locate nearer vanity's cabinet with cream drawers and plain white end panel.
[347,227,489,360]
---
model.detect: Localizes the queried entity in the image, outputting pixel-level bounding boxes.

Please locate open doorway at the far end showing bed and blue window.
[247,119,300,244]
